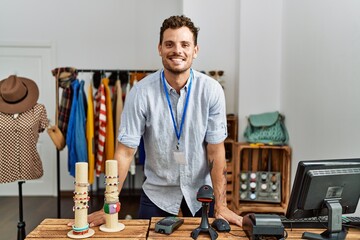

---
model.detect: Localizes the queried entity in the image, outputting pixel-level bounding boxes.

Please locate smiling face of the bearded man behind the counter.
[158,27,198,74]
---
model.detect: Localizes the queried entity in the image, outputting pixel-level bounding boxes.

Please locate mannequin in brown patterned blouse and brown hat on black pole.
[0,75,48,240]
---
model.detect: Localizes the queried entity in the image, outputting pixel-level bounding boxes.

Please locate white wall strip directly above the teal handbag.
[237,0,282,135]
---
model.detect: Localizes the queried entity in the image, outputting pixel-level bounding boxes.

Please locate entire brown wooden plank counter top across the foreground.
[26,217,360,240]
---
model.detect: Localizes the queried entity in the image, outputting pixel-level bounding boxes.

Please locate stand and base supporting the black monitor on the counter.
[302,199,346,240]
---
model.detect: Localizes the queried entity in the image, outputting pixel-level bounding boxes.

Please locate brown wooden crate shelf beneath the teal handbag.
[232,142,291,215]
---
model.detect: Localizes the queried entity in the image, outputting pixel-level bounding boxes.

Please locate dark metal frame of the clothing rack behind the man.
[55,68,156,218]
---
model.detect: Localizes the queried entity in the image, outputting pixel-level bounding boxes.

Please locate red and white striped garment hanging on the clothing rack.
[95,84,106,176]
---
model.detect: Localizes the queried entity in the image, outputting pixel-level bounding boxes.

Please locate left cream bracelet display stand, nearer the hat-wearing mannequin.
[67,162,95,239]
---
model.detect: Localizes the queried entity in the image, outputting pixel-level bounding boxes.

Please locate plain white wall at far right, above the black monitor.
[280,0,360,214]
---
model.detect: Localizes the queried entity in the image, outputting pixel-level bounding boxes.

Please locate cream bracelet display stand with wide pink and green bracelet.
[100,160,125,232]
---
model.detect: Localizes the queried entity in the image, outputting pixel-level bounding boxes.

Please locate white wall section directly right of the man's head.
[183,0,240,113]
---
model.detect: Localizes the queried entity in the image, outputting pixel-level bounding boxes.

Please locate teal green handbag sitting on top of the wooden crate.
[244,111,289,145]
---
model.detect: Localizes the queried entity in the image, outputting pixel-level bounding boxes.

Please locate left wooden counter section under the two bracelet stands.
[25,218,150,240]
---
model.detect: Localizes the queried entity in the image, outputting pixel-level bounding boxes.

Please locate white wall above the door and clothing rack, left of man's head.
[0,0,181,69]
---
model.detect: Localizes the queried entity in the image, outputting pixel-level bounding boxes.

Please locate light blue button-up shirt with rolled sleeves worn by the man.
[118,70,227,215]
